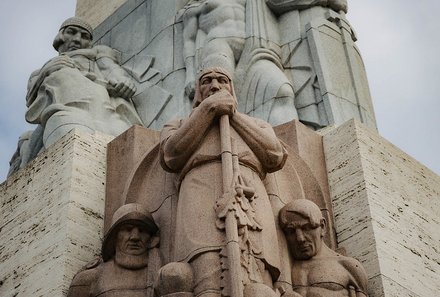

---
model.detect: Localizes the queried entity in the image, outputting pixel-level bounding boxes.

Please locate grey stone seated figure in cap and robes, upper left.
[26,17,142,148]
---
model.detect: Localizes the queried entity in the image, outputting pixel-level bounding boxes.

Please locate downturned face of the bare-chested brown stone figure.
[284,215,325,260]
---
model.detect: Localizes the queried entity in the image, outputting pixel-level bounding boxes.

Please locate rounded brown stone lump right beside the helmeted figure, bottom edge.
[154,262,194,297]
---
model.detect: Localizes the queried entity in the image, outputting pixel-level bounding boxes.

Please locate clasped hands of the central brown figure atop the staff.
[200,90,237,117]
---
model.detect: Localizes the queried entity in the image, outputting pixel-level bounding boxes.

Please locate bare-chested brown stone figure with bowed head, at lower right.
[279,199,367,297]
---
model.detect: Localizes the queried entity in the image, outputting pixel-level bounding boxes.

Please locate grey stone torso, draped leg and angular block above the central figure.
[178,0,376,129]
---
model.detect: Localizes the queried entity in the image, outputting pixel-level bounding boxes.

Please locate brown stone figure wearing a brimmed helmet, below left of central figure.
[67,203,160,297]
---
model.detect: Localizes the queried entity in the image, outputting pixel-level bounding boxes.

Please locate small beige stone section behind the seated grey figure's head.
[76,0,127,28]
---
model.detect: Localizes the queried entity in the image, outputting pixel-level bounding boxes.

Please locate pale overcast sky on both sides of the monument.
[0,0,440,182]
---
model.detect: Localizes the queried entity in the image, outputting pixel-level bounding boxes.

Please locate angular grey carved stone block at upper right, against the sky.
[267,0,376,129]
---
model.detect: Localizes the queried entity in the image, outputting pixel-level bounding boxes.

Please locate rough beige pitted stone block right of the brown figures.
[324,120,440,297]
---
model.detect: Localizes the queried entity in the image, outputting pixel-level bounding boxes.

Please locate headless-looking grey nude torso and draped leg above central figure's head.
[182,0,298,125]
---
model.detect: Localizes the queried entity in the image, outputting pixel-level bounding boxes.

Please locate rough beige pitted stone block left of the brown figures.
[0,130,112,297]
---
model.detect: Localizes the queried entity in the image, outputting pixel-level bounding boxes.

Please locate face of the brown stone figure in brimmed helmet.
[116,224,150,256]
